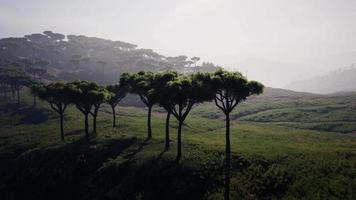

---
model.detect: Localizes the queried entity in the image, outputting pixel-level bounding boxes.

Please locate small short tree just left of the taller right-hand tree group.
[106,85,128,127]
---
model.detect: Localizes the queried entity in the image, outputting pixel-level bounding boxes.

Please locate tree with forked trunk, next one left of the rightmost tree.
[162,73,213,161]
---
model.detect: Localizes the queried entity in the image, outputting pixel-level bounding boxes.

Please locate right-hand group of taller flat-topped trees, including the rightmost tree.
[120,69,264,199]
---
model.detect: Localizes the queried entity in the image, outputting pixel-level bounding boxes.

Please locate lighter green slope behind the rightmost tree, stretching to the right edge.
[193,88,356,133]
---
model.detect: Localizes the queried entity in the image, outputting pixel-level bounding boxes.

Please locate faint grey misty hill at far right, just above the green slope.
[286,64,356,94]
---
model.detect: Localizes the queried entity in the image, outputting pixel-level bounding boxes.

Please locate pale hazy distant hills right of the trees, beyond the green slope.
[229,51,356,93]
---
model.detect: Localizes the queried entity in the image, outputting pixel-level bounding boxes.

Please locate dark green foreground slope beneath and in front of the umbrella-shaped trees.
[0,91,356,199]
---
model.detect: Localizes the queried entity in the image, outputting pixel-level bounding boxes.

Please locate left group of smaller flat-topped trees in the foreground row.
[31,81,127,141]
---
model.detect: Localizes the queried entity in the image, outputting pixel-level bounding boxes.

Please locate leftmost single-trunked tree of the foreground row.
[31,82,73,141]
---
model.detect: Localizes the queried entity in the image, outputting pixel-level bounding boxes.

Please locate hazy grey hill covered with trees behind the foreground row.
[0,31,216,84]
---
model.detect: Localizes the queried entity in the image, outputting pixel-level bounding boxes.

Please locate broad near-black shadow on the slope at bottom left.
[0,138,136,199]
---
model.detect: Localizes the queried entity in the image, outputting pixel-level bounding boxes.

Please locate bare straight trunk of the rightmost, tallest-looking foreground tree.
[224,113,231,200]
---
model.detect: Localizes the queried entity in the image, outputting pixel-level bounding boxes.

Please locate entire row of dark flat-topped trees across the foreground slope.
[32,69,264,199]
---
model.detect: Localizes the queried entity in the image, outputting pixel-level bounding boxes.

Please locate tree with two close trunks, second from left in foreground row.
[70,81,108,141]
